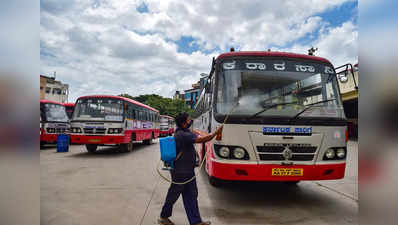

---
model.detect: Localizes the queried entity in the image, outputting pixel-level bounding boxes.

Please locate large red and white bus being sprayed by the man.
[193,52,347,186]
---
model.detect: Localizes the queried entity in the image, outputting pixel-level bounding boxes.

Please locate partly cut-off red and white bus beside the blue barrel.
[40,100,69,146]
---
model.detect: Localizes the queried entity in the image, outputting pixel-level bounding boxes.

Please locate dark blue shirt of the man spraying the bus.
[174,127,198,173]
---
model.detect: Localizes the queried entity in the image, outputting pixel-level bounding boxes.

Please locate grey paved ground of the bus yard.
[40,142,358,225]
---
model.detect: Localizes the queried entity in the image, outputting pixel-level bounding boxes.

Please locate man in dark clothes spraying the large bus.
[158,112,223,225]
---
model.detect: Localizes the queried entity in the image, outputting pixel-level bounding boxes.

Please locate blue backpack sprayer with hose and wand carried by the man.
[156,102,239,184]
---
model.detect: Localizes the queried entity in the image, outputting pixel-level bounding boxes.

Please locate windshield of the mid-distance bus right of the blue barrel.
[72,98,123,122]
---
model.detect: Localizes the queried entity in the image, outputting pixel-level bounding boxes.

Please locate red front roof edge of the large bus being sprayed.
[217,51,331,64]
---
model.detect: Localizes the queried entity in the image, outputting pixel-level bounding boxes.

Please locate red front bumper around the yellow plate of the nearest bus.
[208,160,346,181]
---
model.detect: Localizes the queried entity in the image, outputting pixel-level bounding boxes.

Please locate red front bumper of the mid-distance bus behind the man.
[70,134,124,145]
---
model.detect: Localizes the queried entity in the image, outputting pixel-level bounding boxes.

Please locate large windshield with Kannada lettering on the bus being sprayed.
[216,59,345,118]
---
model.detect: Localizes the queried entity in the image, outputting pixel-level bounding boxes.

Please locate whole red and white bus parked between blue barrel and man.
[71,95,159,152]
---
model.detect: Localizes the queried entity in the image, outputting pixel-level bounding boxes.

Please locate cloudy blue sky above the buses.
[40,0,358,101]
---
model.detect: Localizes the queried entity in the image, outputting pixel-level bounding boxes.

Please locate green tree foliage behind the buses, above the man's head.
[119,94,193,117]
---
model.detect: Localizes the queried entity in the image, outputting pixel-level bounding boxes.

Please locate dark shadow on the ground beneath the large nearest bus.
[198,167,347,224]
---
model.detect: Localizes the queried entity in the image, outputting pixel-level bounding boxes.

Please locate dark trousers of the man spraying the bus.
[160,171,202,225]
